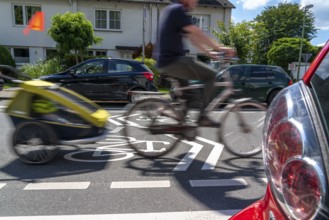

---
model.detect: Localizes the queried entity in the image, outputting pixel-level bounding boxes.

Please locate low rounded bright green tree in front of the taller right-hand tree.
[267,38,318,71]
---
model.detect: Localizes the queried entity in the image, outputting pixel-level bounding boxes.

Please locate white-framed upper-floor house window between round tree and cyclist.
[95,10,121,30]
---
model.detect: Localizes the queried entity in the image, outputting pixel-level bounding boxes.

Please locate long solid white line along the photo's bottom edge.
[0,209,240,220]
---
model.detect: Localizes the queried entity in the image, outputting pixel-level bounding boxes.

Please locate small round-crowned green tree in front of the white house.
[48,12,102,63]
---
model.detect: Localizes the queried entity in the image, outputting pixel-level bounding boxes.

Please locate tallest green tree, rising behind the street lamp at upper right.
[254,2,317,63]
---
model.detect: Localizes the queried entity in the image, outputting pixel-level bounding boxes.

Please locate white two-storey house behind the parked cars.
[0,0,235,65]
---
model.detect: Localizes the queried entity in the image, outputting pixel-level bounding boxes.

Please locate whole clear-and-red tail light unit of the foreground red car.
[263,81,326,220]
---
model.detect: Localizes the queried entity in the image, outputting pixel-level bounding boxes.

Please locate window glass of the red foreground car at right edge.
[311,51,329,134]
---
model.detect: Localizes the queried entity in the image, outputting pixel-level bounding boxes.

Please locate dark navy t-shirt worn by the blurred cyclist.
[157,3,192,67]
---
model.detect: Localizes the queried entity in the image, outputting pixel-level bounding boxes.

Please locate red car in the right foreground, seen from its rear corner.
[231,41,329,220]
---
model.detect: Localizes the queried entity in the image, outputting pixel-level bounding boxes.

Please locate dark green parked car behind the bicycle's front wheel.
[217,64,292,105]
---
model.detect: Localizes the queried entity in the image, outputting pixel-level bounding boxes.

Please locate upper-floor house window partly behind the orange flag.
[13,5,41,26]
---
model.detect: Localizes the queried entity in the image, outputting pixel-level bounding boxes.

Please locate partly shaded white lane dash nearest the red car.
[190,179,248,187]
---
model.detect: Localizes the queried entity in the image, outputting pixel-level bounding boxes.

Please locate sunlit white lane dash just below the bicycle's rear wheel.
[111,180,170,189]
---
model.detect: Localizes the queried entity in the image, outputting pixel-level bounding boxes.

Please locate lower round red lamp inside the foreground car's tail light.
[281,158,322,219]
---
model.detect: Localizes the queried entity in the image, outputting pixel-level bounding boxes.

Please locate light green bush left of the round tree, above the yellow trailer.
[21,58,63,79]
